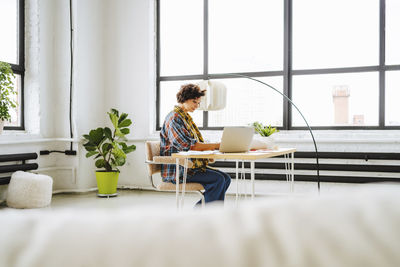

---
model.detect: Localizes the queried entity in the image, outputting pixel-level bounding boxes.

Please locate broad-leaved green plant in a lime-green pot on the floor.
[83,109,136,197]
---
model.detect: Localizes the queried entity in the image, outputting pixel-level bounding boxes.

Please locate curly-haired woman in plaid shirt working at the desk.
[160,84,231,204]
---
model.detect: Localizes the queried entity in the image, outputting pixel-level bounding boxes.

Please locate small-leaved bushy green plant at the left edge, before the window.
[0,61,17,133]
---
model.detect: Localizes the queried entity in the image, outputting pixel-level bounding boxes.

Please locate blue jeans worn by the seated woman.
[187,168,231,204]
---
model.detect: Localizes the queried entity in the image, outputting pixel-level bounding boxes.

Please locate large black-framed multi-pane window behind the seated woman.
[157,0,400,130]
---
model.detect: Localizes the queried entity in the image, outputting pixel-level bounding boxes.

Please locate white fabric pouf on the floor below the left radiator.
[7,171,53,209]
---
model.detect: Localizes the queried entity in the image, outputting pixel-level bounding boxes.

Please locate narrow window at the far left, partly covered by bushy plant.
[0,0,25,130]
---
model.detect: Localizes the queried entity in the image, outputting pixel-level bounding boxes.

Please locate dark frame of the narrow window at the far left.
[4,0,25,130]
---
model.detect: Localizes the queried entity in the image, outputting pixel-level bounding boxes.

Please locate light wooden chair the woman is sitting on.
[145,141,205,208]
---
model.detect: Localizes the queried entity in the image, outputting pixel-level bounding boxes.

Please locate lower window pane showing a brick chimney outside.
[292,72,379,126]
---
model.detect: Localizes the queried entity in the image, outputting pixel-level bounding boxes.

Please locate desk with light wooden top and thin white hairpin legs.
[171,148,296,207]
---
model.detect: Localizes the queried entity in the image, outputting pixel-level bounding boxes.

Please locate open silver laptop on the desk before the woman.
[219,126,254,153]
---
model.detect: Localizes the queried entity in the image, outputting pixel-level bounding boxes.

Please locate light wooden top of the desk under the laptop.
[171,148,296,160]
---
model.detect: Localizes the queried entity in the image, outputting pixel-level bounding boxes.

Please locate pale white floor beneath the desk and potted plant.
[9,181,363,214]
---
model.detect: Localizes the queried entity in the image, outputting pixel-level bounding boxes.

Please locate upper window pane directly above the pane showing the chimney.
[293,0,379,69]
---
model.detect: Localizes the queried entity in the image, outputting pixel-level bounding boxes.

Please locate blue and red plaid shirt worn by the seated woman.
[160,111,197,182]
